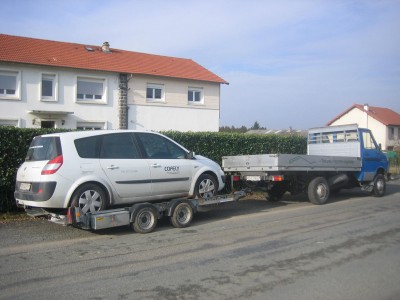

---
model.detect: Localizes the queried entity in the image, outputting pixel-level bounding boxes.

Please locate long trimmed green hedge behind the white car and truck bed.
[0,127,307,212]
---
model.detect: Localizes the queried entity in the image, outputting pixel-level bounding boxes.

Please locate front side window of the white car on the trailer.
[137,133,187,159]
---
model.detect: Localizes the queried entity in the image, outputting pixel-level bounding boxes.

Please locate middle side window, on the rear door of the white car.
[100,133,140,159]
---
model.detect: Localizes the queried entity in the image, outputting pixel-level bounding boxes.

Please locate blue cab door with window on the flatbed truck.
[360,129,387,181]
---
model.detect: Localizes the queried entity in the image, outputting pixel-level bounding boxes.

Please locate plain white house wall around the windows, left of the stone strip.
[0,64,119,129]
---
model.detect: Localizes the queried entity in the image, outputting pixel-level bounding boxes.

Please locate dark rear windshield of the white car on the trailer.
[25,136,62,161]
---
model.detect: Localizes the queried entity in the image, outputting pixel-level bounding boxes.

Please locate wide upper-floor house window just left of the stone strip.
[76,77,106,102]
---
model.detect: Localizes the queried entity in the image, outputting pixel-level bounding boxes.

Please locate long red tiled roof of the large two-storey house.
[0,34,228,84]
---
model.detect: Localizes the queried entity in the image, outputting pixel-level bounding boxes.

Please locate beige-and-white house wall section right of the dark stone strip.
[128,76,220,131]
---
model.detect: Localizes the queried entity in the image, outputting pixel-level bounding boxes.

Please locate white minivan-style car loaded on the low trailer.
[14,130,224,212]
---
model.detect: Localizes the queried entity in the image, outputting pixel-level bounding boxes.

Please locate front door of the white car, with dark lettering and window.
[136,133,194,199]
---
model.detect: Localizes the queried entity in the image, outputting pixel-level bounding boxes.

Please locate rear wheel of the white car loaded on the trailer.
[71,183,108,213]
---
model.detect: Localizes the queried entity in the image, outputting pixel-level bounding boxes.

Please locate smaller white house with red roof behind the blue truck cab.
[327,104,400,150]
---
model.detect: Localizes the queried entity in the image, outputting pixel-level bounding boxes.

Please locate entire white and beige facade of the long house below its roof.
[0,63,220,131]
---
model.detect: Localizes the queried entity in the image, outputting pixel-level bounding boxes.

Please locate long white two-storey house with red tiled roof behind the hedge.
[0,34,227,131]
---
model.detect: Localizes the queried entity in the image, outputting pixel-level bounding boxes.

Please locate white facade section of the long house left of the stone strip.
[0,63,119,129]
